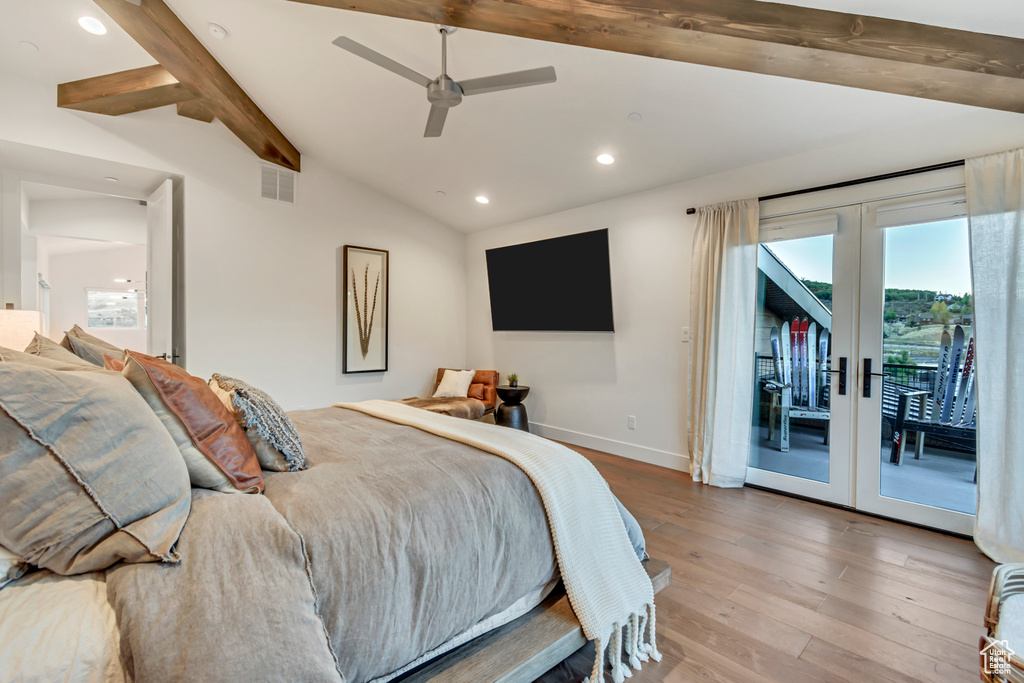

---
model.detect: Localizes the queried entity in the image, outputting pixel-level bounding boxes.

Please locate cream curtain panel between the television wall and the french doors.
[686,199,758,487]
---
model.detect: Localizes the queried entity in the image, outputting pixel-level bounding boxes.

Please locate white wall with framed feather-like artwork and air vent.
[0,69,466,409]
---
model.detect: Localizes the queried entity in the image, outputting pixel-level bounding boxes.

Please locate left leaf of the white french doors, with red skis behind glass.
[748,209,858,504]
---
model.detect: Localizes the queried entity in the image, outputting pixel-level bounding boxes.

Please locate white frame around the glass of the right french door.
[853,187,974,536]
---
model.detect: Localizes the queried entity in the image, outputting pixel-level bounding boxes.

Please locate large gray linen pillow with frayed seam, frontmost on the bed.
[0,349,190,574]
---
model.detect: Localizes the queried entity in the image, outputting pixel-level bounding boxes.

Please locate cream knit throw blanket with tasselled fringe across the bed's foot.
[336,400,662,683]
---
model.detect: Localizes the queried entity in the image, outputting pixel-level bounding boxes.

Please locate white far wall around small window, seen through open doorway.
[46,242,146,352]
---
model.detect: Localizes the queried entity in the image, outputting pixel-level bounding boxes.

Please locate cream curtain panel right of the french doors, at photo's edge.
[966,150,1024,562]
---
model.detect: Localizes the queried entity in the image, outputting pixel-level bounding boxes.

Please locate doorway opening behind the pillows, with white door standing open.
[0,140,185,367]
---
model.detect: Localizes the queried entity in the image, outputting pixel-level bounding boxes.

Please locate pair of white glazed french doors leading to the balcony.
[748,173,977,535]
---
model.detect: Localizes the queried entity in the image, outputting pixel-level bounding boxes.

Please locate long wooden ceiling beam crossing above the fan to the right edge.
[291,0,1024,113]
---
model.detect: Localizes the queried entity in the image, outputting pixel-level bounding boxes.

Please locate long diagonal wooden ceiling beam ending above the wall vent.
[94,0,301,171]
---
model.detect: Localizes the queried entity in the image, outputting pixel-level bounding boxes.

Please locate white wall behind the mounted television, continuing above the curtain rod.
[467,113,1024,469]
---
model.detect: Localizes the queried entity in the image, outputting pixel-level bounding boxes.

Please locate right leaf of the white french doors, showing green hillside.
[856,195,977,533]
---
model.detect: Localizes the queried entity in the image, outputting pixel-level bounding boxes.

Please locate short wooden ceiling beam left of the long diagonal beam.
[57,65,195,116]
